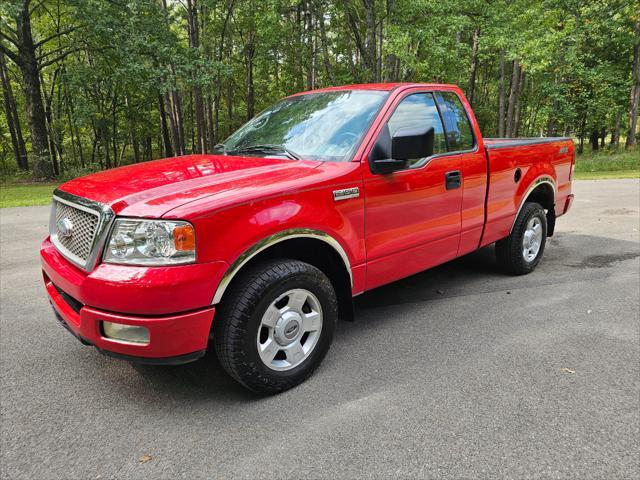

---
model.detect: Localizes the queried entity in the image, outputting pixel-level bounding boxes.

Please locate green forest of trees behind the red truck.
[0,0,640,179]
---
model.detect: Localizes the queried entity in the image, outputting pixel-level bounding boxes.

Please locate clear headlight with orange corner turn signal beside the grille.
[104,218,196,265]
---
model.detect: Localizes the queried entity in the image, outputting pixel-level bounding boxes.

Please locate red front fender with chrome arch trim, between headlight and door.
[165,162,365,303]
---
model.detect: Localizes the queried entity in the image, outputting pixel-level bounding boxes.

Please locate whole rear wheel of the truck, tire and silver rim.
[496,202,547,275]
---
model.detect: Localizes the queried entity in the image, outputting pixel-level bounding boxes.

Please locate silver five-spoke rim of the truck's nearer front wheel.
[257,288,322,371]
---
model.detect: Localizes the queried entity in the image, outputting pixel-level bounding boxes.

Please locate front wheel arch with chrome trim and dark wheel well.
[211,228,353,320]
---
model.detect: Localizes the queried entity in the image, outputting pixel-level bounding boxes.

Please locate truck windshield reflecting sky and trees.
[219,90,387,162]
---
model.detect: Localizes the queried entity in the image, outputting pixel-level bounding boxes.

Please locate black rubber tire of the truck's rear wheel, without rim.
[496,202,547,275]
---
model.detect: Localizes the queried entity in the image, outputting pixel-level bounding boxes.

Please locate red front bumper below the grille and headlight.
[41,240,226,364]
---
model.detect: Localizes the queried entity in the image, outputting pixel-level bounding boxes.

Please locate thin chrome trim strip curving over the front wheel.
[211,228,353,305]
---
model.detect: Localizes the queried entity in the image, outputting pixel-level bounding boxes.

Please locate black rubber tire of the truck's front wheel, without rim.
[213,259,338,394]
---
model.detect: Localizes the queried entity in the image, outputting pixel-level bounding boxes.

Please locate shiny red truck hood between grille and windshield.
[60,155,321,218]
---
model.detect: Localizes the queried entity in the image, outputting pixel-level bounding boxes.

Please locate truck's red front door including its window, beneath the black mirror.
[363,90,463,289]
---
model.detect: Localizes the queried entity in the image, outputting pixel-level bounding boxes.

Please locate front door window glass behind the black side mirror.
[387,93,447,166]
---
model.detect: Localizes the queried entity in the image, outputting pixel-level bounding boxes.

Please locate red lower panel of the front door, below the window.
[364,156,463,289]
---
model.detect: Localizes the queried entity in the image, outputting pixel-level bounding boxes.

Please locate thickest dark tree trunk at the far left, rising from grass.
[16,2,53,179]
